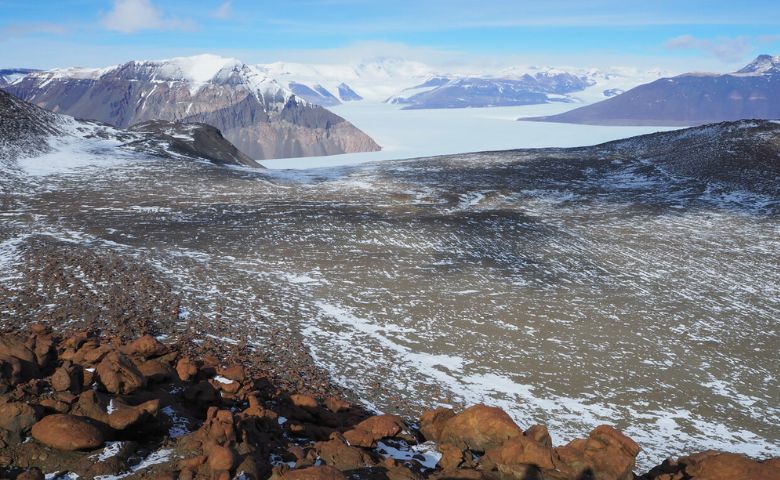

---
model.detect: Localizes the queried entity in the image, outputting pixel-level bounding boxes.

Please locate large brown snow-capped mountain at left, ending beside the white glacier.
[3,55,379,159]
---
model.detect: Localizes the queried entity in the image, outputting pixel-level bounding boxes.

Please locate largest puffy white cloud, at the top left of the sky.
[101,0,194,33]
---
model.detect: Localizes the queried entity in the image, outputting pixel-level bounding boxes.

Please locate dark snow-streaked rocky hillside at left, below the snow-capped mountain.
[0,90,260,168]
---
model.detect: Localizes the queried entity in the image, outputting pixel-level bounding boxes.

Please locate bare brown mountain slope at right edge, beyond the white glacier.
[525,55,780,125]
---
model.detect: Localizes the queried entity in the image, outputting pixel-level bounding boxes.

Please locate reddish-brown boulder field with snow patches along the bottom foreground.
[0,324,780,480]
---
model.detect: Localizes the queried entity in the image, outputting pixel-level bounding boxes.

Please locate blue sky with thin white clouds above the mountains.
[0,0,780,71]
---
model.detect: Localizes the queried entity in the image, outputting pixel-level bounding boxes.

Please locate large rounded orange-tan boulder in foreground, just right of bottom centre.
[439,405,523,452]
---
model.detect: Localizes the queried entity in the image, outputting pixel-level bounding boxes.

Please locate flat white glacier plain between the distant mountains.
[261,102,669,169]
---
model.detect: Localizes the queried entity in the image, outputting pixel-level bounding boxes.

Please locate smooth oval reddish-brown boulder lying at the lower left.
[32,414,103,451]
